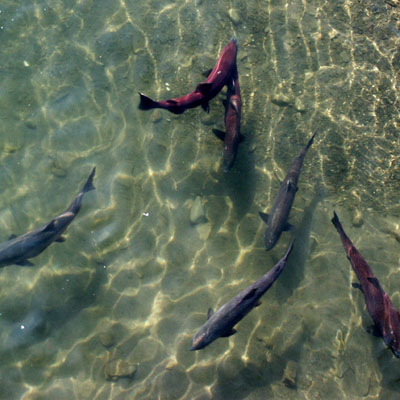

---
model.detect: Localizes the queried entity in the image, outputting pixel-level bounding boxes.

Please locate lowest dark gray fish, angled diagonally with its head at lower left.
[190,242,293,350]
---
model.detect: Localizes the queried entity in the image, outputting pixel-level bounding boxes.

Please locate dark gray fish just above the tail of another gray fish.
[259,133,316,250]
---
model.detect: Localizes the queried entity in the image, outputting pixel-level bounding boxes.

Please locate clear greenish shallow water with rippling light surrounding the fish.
[0,0,400,400]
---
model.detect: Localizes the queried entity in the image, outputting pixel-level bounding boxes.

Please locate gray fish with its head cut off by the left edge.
[0,167,96,267]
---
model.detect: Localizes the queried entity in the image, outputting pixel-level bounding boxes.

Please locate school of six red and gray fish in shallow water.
[0,38,400,372]
